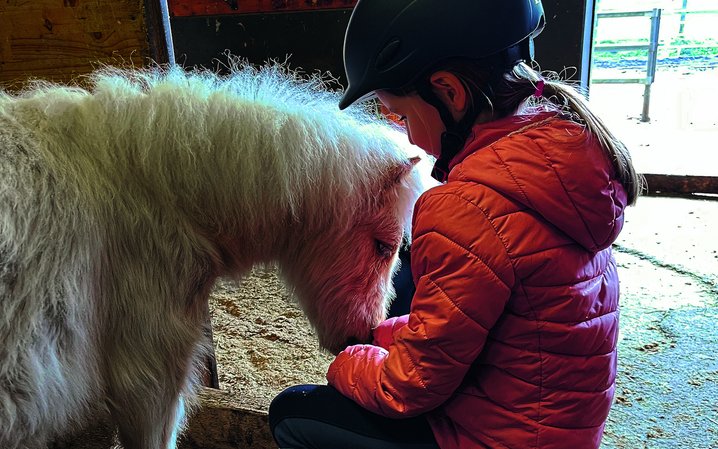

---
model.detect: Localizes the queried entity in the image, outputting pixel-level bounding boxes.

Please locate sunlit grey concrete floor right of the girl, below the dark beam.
[602,197,718,449]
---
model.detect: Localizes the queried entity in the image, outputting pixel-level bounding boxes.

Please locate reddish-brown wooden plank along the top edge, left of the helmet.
[169,0,357,17]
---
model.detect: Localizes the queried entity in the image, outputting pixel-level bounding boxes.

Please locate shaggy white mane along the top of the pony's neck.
[0,65,422,252]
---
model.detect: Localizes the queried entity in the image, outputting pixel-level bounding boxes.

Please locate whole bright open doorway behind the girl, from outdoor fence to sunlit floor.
[587,0,718,449]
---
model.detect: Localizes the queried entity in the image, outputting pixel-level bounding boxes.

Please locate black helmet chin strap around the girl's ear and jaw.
[417,81,477,182]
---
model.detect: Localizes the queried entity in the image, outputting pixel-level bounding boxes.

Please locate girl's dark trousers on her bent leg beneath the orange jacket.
[269,385,439,449]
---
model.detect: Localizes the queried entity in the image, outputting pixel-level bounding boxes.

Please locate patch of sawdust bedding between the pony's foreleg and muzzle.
[210,268,333,411]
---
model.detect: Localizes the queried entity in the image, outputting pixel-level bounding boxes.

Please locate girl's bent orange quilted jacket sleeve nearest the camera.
[327,186,514,417]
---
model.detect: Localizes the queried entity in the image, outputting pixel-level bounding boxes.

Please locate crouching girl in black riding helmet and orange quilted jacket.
[269,0,641,449]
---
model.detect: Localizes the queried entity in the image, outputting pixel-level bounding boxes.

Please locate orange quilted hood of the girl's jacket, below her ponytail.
[448,112,627,252]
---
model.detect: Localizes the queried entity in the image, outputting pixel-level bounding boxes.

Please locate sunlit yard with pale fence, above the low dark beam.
[589,0,718,177]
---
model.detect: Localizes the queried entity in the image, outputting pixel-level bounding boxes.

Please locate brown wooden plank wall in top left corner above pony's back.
[0,0,171,89]
